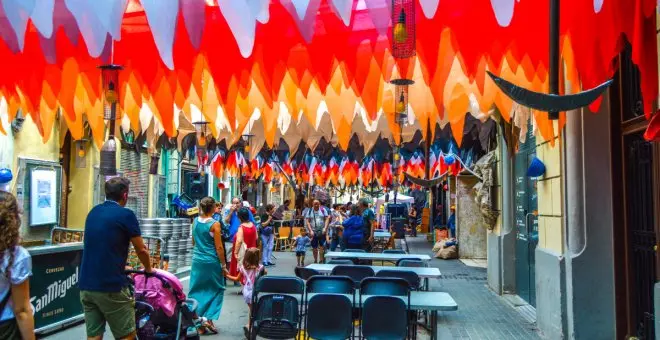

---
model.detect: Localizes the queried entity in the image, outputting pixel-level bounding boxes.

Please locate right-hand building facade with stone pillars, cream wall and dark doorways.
[488,45,660,339]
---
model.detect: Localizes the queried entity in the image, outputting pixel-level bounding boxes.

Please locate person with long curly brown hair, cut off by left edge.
[0,191,35,340]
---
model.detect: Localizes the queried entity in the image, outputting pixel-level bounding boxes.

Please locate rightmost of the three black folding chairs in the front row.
[360,277,413,339]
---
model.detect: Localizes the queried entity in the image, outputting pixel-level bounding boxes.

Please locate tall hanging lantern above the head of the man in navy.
[99,64,123,176]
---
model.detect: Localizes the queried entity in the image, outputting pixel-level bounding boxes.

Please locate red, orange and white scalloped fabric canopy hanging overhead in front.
[0,0,658,152]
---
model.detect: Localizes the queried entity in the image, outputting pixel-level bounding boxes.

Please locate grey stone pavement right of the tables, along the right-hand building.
[406,237,540,340]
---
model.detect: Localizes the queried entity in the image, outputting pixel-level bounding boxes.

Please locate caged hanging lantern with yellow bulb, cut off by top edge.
[392,0,415,59]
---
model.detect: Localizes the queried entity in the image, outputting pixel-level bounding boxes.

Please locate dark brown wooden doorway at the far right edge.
[610,47,660,339]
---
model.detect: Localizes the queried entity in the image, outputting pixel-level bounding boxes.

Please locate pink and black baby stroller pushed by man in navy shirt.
[127,269,199,340]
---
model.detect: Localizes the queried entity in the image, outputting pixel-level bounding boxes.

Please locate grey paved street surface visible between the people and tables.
[46,237,539,340]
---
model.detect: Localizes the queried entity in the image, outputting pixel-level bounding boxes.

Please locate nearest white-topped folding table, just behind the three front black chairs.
[286,291,458,340]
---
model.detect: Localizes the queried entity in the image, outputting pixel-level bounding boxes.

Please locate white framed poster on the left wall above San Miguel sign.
[30,170,57,226]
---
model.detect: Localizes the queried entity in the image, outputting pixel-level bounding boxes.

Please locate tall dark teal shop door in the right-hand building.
[514,131,538,307]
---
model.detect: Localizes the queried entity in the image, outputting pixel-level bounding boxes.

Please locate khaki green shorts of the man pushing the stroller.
[80,288,135,339]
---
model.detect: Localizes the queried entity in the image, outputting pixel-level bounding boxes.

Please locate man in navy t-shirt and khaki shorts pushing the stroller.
[79,177,151,340]
